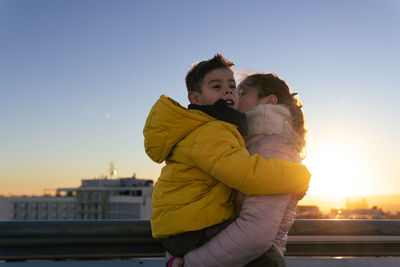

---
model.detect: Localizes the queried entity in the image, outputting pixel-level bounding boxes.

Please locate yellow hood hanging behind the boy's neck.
[143,95,216,163]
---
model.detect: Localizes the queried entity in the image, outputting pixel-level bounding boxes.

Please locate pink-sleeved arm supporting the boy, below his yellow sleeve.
[184,195,290,267]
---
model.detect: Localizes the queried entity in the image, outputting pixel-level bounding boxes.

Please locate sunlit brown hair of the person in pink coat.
[241,73,307,157]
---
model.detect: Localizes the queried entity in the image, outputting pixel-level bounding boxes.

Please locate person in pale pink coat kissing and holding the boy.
[173,73,306,267]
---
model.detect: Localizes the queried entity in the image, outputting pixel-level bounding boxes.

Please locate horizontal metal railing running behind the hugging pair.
[0,220,400,260]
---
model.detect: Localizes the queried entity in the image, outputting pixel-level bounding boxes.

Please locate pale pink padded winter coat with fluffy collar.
[184,104,300,267]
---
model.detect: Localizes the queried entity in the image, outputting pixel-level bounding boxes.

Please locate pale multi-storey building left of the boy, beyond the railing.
[0,177,153,220]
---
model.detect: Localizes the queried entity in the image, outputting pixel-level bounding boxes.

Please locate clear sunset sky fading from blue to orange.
[0,0,400,196]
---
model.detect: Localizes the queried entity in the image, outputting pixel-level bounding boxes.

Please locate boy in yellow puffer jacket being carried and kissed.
[143,54,311,257]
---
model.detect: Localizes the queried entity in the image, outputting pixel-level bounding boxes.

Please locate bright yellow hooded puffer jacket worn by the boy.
[143,96,311,238]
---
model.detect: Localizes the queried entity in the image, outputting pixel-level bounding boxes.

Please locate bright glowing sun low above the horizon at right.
[304,145,374,197]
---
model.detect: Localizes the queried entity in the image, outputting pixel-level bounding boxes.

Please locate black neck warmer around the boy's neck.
[188,99,247,136]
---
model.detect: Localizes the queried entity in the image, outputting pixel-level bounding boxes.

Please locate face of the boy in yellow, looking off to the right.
[188,68,239,109]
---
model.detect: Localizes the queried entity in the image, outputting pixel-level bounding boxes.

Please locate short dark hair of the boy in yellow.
[185,54,235,93]
